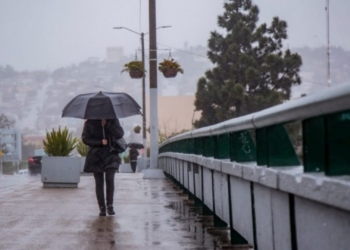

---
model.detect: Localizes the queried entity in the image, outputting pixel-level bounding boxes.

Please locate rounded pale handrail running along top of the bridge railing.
[159,84,350,147]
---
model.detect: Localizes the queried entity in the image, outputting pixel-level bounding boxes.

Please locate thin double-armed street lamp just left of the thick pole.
[113,25,171,157]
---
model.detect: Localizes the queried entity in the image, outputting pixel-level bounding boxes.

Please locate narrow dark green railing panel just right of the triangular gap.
[303,117,326,173]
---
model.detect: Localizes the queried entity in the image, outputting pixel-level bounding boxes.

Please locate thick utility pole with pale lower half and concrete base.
[143,0,165,178]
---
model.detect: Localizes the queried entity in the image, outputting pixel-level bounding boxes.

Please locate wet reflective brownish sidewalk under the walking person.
[0,173,242,250]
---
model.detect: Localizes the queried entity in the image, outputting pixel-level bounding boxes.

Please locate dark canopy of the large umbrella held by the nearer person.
[62,91,141,120]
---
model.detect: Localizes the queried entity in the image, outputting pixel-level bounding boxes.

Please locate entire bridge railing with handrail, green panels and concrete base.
[158,85,350,250]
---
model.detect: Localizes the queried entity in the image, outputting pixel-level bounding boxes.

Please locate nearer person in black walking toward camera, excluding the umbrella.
[82,119,124,216]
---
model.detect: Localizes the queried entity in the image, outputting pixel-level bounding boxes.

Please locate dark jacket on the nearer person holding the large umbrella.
[82,120,124,173]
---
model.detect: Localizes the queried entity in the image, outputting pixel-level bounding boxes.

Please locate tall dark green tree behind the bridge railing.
[194,0,302,127]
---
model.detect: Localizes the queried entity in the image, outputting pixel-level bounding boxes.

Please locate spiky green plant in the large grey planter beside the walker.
[43,127,79,156]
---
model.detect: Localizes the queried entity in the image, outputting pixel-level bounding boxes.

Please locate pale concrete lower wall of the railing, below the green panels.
[159,153,350,250]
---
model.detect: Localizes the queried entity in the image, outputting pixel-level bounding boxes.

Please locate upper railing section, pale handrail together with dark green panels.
[160,84,350,175]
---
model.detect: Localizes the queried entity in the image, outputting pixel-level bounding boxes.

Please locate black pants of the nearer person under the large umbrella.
[94,168,116,207]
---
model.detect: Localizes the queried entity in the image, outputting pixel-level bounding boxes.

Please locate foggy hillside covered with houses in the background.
[0,46,350,146]
